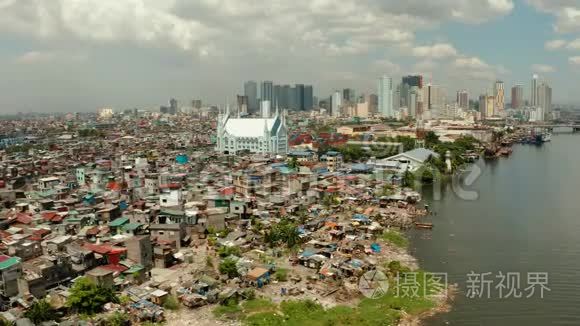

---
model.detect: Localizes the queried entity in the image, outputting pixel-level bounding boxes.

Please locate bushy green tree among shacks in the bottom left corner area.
[66,277,119,315]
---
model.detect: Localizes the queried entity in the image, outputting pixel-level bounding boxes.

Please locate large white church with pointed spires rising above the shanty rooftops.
[216,102,288,154]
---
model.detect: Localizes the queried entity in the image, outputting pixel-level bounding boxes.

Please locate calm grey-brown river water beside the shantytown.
[410,134,580,326]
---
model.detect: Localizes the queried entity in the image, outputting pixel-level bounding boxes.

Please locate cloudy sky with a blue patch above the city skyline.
[0,0,580,113]
